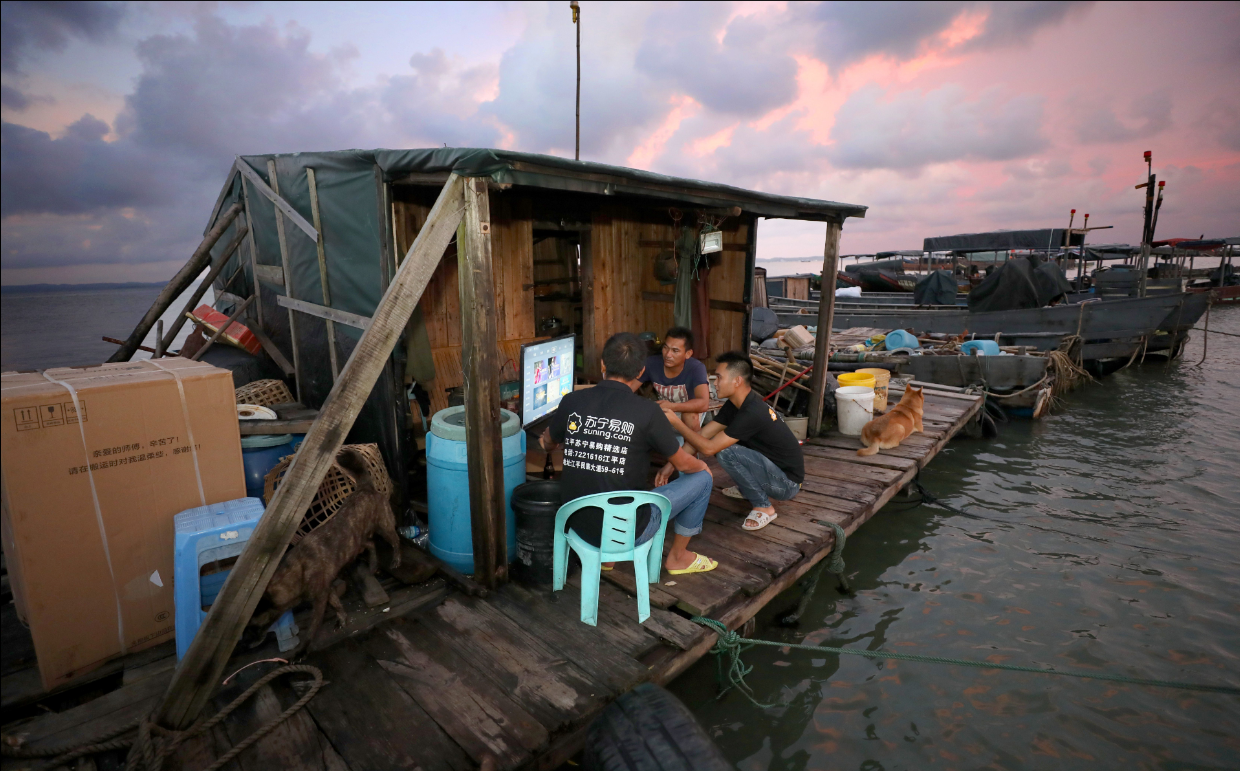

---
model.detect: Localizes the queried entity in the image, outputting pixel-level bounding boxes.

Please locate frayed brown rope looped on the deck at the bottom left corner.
[0,664,325,771]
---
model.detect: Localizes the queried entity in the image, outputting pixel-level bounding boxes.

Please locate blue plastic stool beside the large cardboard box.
[172,498,298,661]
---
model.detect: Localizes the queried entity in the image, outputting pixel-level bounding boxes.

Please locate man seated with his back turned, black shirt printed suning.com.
[542,332,718,575]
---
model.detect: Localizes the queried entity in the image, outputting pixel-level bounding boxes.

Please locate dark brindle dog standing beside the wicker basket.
[250,450,401,658]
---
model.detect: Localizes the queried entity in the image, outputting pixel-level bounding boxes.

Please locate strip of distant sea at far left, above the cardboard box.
[0,286,212,372]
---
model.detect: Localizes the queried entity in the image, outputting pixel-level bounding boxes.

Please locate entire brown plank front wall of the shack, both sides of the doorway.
[393,188,751,412]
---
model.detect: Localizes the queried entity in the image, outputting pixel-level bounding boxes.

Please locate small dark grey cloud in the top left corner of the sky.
[0,0,125,73]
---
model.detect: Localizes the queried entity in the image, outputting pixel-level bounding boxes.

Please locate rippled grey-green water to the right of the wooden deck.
[673,307,1240,771]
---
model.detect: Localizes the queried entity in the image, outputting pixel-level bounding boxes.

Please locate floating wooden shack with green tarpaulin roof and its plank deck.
[4,149,1001,769]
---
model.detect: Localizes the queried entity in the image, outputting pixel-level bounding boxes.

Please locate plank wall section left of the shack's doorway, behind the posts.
[393,191,534,414]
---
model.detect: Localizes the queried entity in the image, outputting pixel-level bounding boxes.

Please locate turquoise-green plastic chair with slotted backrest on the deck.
[552,490,672,626]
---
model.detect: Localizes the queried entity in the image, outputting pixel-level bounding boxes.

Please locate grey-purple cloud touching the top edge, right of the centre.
[801,1,1092,67]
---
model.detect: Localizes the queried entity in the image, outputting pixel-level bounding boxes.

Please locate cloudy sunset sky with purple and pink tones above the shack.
[0,0,1240,285]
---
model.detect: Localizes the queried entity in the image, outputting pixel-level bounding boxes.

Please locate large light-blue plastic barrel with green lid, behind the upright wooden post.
[427,407,526,575]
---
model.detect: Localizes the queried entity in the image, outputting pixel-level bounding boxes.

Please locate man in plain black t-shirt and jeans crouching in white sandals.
[663,352,805,531]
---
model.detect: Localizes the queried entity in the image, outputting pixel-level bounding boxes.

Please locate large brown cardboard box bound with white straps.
[0,357,246,689]
